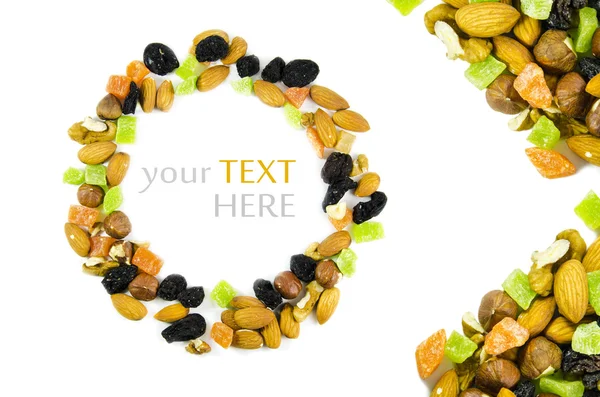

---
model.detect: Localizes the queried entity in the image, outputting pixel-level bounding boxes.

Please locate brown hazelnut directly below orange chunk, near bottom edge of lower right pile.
[475,358,521,396]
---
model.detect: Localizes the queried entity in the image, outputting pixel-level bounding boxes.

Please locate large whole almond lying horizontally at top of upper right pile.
[456,3,521,39]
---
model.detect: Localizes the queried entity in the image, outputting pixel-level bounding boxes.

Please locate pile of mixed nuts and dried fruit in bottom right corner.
[415,229,600,397]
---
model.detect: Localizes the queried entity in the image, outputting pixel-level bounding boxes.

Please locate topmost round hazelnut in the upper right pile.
[533,30,577,74]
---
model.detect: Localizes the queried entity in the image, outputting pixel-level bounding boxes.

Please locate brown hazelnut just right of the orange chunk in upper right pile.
[556,72,591,118]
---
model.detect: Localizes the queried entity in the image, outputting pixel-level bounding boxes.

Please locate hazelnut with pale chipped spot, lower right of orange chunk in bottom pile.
[519,336,562,379]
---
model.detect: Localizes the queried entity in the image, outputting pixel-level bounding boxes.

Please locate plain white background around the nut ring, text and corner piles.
[0,0,598,396]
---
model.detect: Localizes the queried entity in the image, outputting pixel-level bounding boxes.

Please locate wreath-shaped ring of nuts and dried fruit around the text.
[63,30,387,354]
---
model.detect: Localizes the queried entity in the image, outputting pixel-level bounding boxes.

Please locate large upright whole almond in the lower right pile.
[554,259,588,323]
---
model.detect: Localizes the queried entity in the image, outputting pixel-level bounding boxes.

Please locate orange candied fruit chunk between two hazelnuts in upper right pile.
[513,62,552,109]
